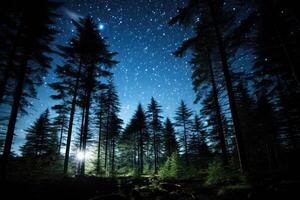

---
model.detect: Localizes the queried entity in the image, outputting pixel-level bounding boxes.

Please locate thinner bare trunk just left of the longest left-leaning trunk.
[208,52,228,166]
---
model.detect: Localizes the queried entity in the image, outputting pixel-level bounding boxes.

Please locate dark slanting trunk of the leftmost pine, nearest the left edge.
[1,55,28,180]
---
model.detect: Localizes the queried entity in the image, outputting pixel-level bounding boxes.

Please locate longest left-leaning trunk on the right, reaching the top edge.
[209,0,247,173]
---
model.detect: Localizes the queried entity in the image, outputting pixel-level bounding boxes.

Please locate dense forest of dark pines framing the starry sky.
[0,0,300,199]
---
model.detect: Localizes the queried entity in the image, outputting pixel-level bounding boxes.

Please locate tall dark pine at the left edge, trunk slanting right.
[0,0,59,177]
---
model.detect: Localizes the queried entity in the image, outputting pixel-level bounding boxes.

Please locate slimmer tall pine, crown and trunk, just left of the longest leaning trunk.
[175,16,228,165]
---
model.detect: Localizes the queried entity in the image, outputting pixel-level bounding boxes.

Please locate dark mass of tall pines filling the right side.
[170,0,300,176]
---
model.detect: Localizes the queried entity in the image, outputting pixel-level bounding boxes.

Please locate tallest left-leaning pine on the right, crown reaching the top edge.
[170,0,254,172]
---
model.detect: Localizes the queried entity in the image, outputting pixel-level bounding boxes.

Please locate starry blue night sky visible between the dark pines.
[14,0,199,151]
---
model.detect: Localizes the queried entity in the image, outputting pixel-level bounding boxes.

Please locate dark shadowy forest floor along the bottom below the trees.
[0,177,300,200]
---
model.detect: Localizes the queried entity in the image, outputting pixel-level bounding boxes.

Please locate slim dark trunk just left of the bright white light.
[64,61,82,175]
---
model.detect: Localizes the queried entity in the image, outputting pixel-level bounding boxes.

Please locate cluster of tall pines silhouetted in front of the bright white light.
[51,17,118,175]
